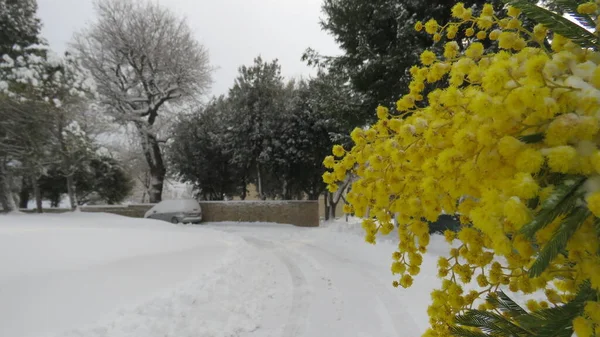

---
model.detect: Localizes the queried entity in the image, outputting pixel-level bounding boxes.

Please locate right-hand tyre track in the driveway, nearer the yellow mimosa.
[303,242,421,336]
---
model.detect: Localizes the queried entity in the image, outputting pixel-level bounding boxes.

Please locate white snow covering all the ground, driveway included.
[0,213,445,337]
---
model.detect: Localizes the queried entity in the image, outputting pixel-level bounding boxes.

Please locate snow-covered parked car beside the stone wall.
[144,199,202,224]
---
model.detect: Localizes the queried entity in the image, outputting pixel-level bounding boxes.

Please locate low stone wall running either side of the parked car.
[22,201,319,227]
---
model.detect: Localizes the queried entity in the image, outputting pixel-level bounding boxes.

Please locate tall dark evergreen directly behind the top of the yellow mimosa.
[303,0,502,117]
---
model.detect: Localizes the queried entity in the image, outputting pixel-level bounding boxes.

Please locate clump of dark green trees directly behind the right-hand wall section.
[168,57,362,205]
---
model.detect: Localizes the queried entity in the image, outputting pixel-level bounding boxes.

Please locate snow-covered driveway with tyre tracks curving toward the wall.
[211,224,428,337]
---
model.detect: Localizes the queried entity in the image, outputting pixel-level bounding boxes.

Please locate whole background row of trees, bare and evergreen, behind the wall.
[0,0,510,210]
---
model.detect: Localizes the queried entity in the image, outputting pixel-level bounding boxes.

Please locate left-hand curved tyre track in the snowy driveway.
[243,236,310,337]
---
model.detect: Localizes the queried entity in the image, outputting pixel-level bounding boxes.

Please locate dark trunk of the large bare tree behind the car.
[136,123,167,203]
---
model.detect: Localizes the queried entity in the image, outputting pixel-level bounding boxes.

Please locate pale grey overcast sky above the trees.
[38,0,339,95]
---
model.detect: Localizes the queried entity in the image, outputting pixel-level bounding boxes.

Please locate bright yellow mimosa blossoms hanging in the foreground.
[323,2,600,336]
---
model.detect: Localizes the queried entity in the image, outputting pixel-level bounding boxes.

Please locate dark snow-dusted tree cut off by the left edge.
[0,0,57,211]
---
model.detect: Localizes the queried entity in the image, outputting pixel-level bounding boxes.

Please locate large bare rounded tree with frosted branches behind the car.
[73,0,212,202]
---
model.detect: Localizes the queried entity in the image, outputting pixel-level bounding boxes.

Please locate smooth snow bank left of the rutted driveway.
[0,213,270,337]
